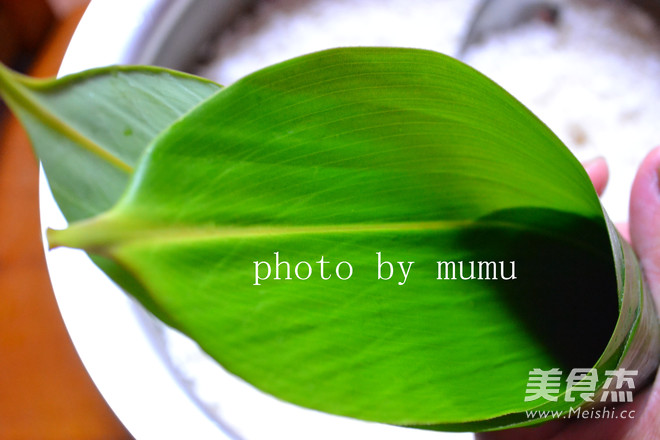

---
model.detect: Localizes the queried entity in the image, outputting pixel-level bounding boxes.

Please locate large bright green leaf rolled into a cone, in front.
[14,48,658,430]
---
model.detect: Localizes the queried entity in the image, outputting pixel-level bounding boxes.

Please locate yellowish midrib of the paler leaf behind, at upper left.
[0,63,133,174]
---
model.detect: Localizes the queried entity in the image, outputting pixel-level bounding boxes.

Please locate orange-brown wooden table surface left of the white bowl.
[0,0,131,440]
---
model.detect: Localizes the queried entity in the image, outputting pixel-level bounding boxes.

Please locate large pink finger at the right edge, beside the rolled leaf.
[629,147,660,304]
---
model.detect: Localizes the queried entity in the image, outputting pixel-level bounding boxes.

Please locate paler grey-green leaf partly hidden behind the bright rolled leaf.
[0,65,220,316]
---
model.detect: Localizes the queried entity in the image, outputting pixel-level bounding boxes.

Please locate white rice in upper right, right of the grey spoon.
[466,0,660,222]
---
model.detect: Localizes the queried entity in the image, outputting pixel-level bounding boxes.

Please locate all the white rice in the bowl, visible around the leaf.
[165,0,660,440]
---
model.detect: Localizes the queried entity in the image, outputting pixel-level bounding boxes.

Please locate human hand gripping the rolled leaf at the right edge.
[477,147,660,440]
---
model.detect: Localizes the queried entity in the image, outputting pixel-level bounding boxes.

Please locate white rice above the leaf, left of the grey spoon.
[200,0,478,85]
